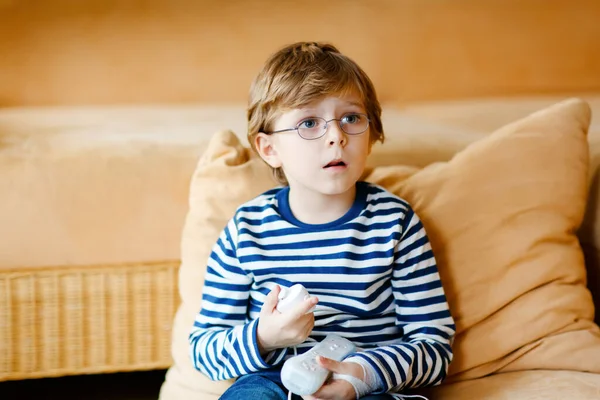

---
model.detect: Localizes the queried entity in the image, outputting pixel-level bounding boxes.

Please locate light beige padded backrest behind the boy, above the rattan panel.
[0,104,481,269]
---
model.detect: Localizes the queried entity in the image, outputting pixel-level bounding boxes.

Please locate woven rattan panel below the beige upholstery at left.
[0,261,179,381]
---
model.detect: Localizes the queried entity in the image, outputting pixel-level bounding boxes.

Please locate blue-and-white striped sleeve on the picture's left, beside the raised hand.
[189,220,286,380]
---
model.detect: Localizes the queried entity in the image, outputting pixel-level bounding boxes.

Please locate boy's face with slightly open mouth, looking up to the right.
[257,94,371,195]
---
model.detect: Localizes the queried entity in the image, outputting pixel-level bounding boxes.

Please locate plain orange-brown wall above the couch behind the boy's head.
[0,0,600,106]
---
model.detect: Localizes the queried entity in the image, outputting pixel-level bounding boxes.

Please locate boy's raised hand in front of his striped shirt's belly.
[257,285,319,354]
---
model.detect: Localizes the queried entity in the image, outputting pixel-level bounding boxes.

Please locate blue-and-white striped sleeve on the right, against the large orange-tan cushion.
[345,208,456,393]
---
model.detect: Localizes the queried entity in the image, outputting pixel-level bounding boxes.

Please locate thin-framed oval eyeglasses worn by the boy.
[265,113,369,140]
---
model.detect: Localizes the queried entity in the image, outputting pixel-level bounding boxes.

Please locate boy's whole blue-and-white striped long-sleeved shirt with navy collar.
[189,182,455,393]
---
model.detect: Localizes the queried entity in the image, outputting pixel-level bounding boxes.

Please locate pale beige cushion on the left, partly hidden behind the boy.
[161,131,275,400]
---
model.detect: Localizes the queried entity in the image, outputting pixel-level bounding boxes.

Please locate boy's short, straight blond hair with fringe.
[248,42,384,185]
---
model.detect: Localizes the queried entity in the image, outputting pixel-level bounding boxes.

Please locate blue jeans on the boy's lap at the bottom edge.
[219,368,392,400]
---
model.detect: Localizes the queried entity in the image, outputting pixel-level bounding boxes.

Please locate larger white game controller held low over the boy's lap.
[281,334,356,396]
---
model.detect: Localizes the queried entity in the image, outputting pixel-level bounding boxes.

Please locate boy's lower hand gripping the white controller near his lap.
[302,356,364,400]
